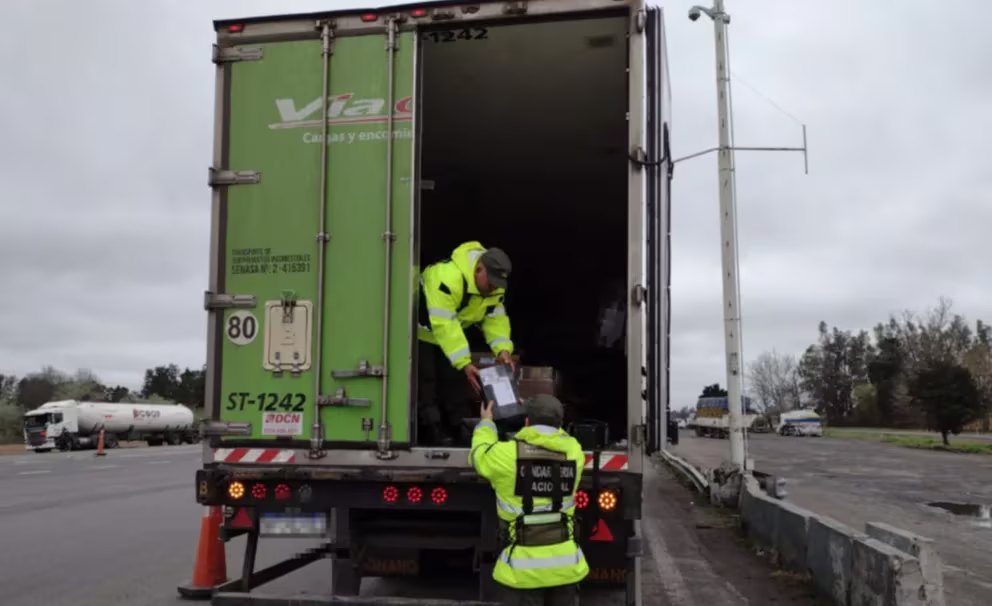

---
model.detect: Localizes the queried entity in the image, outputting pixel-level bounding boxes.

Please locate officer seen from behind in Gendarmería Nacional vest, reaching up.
[469,395,589,606]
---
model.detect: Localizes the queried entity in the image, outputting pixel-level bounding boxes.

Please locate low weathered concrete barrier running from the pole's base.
[684,456,944,606]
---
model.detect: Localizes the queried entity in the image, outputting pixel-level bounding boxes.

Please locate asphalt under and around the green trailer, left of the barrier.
[0,446,813,606]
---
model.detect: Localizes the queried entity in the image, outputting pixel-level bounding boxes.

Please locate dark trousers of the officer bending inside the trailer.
[417,341,470,446]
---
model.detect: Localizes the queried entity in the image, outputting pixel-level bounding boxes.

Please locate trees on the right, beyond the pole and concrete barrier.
[746,298,992,443]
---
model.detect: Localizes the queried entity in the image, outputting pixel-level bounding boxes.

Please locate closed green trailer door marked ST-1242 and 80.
[209,25,416,448]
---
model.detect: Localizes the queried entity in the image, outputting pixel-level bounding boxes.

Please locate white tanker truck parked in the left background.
[24,400,199,452]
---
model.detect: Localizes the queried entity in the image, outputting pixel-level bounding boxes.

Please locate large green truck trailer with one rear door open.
[187,0,678,604]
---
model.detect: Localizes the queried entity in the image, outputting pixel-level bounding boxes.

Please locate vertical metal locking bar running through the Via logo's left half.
[310,21,332,459]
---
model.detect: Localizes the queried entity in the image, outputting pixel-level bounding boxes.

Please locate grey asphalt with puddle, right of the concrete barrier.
[674,430,992,606]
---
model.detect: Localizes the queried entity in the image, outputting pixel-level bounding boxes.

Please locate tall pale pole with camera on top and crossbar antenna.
[688,0,809,472]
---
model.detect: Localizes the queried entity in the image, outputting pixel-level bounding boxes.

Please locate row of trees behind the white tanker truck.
[0,364,206,440]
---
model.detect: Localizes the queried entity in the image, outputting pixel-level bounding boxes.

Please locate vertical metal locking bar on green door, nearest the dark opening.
[376,16,398,459]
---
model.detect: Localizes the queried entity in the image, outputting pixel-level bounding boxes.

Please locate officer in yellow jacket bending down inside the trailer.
[417,241,513,443]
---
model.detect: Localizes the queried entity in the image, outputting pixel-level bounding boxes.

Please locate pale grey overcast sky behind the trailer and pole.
[0,0,992,408]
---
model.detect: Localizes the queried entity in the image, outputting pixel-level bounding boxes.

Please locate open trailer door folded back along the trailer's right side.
[645,2,678,453]
